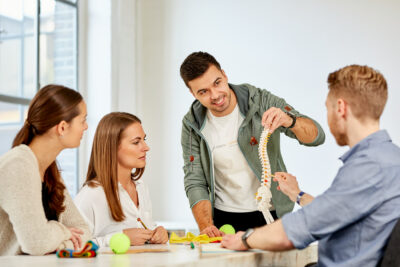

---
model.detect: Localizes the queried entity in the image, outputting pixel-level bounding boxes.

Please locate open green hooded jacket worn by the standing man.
[181,84,325,217]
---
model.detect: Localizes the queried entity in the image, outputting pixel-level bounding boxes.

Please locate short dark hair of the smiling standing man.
[181,51,221,88]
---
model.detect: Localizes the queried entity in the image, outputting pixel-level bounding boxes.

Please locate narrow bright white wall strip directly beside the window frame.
[78,0,111,182]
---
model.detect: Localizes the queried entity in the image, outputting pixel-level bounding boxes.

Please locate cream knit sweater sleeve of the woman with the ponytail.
[0,157,71,255]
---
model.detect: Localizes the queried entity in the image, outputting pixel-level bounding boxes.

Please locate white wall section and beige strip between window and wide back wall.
[79,0,136,184]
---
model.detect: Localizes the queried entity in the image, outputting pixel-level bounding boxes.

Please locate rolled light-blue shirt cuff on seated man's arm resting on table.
[282,210,316,249]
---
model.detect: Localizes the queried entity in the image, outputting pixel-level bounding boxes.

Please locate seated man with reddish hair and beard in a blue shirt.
[222,65,400,267]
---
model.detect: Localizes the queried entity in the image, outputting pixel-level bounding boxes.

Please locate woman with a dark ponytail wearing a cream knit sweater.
[0,85,90,256]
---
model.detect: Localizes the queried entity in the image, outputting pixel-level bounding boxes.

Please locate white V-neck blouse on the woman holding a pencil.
[74,180,156,247]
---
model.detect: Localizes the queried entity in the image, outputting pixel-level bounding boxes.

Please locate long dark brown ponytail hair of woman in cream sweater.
[12,84,83,217]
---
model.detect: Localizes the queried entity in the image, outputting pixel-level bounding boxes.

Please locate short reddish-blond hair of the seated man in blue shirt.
[328,65,388,120]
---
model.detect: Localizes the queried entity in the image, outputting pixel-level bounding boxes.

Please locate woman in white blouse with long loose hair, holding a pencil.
[75,112,168,247]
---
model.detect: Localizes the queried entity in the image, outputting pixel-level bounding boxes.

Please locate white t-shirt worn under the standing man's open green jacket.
[201,105,260,212]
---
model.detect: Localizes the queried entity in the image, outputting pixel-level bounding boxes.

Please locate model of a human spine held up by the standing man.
[256,129,274,224]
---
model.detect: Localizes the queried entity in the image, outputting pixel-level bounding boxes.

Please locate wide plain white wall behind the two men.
[136,0,400,226]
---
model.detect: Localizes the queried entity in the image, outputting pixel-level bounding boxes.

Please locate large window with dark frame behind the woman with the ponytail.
[0,0,78,195]
